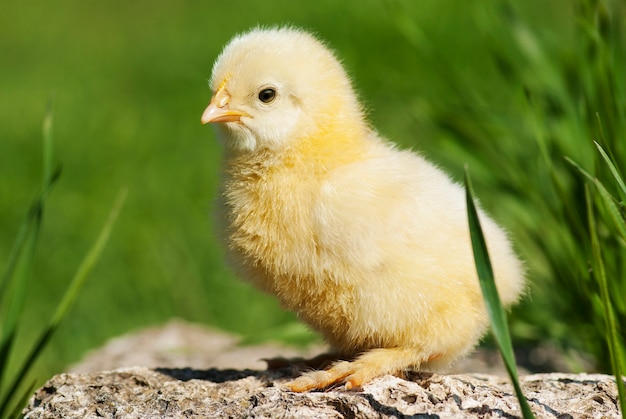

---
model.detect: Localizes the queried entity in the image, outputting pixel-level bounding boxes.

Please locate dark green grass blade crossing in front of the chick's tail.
[465,166,534,419]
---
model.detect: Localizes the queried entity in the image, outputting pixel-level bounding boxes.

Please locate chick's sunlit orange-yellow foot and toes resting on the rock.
[287,348,438,392]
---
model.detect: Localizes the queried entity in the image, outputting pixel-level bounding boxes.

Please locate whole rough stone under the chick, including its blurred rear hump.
[24,320,618,418]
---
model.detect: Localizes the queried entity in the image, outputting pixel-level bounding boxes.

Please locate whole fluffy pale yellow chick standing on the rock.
[201,28,524,391]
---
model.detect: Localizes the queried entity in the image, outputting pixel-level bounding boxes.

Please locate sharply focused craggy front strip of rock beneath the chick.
[23,366,619,419]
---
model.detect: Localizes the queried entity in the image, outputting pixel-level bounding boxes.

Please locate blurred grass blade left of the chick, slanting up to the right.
[0,189,127,417]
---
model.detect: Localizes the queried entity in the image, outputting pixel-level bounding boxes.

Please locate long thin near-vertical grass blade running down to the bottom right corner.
[585,185,626,419]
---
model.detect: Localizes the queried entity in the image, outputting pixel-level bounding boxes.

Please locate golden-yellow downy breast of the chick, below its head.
[218,147,352,337]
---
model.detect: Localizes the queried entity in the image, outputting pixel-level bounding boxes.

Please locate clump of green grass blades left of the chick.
[0,106,126,418]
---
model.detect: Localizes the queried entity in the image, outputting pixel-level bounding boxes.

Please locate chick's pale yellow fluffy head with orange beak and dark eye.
[202,28,363,151]
